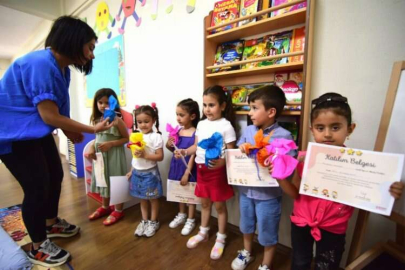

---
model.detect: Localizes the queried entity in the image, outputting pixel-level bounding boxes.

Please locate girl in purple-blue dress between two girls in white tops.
[166,98,200,235]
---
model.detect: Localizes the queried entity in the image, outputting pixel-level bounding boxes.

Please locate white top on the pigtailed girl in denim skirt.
[132,132,163,170]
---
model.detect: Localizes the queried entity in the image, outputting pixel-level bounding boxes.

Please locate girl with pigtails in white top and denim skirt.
[127,103,163,237]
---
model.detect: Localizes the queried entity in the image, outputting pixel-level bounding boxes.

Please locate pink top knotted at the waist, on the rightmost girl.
[291,152,354,241]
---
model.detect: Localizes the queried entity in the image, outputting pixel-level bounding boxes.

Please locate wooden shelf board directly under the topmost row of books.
[207,8,307,44]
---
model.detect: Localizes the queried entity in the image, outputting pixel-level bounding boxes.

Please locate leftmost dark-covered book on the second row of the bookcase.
[212,40,243,72]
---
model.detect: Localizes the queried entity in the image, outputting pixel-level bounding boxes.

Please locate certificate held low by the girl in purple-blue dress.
[167,179,201,204]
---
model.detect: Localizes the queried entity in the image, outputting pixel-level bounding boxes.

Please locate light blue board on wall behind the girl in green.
[84,35,127,108]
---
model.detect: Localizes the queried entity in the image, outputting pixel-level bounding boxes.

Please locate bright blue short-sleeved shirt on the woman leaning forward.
[0,49,70,154]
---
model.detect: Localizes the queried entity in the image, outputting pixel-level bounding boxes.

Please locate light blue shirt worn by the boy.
[237,122,296,200]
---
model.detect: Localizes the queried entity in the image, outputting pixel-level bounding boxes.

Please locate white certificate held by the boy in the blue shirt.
[225,149,278,187]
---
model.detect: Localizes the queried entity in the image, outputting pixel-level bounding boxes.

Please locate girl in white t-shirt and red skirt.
[175,85,236,260]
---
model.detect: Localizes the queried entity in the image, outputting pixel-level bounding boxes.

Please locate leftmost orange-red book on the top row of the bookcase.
[211,0,240,34]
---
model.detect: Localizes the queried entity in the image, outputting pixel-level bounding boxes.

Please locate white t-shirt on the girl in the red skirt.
[195,118,236,164]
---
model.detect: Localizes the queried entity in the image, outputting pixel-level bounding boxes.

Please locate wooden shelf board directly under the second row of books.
[206,62,304,79]
